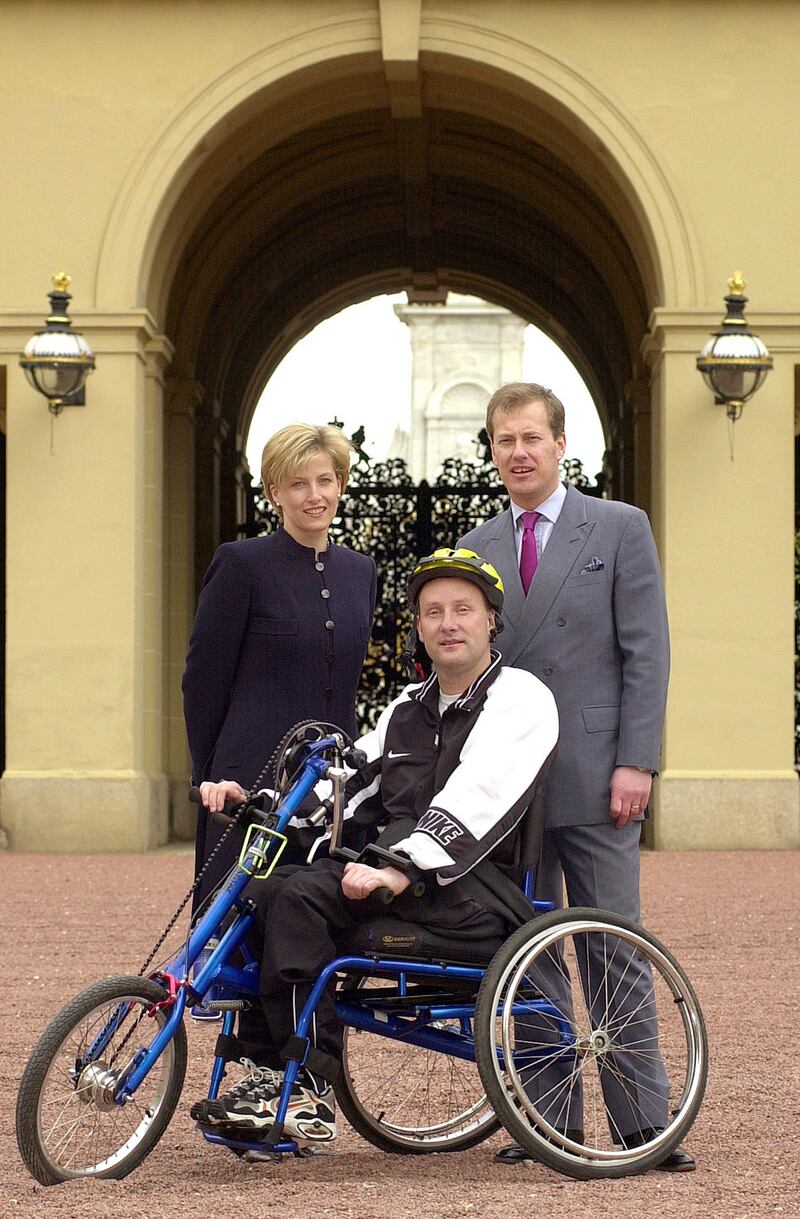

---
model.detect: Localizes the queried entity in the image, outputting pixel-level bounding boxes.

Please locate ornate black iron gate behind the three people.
[239,432,601,728]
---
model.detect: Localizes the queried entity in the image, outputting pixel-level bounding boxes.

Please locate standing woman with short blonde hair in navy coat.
[183,423,377,908]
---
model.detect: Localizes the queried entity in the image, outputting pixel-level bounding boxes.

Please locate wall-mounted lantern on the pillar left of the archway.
[20,271,94,414]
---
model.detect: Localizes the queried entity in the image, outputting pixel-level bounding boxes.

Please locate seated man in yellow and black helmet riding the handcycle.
[191,550,559,1143]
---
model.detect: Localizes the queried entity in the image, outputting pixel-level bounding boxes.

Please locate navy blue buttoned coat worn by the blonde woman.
[183,529,377,892]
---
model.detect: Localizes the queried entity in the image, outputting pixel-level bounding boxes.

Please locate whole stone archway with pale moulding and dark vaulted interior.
[96,16,699,838]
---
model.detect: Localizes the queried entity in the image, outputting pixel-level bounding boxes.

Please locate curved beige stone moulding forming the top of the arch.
[95,16,704,316]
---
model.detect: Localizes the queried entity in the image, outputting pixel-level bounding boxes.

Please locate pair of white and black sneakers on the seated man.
[191,1058,337,1142]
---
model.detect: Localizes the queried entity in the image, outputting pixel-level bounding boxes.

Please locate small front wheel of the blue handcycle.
[17,976,187,1185]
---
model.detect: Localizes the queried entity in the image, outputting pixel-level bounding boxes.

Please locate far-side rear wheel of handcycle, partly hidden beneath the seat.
[335,979,500,1156]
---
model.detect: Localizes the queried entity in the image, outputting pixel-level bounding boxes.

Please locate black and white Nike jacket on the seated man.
[303,652,559,885]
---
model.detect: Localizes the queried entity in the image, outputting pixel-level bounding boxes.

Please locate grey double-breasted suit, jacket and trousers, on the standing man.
[460,486,670,1139]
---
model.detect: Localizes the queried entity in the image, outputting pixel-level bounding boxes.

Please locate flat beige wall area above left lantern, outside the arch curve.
[0,0,346,303]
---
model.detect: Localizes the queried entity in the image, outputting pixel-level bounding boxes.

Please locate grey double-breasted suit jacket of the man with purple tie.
[460,486,670,828]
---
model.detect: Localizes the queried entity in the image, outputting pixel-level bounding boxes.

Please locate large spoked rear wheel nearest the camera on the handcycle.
[476,908,709,1180]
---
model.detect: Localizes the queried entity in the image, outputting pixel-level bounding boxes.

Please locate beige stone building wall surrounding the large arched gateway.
[0,0,800,850]
